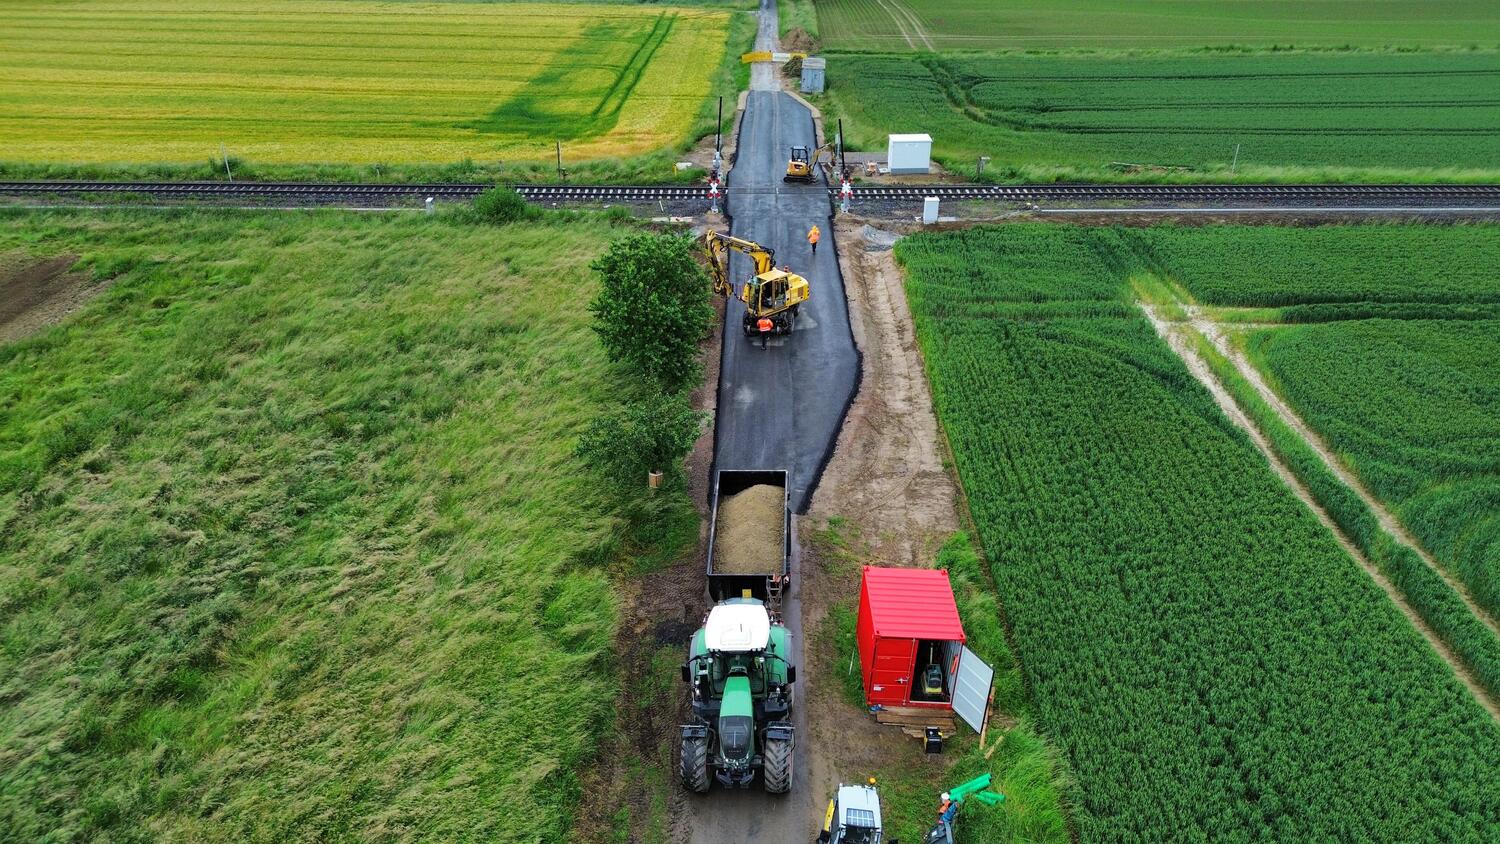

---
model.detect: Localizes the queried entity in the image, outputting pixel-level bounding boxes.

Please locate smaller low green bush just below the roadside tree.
[578,391,708,486]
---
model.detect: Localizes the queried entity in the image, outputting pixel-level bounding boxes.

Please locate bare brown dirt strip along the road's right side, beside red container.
[800,217,959,796]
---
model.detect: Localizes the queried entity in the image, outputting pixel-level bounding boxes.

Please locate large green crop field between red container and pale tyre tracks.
[897,226,1500,841]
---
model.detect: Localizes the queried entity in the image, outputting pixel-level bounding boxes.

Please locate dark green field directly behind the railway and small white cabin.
[828,51,1500,181]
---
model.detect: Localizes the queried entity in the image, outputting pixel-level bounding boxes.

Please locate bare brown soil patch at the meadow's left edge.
[0,252,108,343]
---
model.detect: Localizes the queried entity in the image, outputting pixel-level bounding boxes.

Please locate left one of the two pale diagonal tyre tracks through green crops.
[1137,301,1500,721]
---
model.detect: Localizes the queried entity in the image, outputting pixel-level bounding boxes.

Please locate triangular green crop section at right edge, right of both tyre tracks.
[1250,321,1500,618]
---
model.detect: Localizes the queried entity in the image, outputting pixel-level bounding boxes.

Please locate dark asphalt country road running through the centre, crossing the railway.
[687,0,860,844]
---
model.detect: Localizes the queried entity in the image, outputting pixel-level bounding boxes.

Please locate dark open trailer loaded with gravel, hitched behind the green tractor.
[708,469,792,615]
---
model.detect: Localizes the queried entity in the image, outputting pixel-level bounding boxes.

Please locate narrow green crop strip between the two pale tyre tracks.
[1194,334,1500,699]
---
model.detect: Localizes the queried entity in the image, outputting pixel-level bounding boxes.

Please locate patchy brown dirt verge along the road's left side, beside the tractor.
[570,303,723,844]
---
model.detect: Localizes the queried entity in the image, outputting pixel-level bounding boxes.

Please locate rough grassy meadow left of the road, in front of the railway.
[0,211,669,843]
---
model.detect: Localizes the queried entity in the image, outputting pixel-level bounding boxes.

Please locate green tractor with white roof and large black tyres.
[680,598,797,795]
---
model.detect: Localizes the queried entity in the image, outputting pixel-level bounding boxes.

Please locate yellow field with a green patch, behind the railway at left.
[0,0,729,163]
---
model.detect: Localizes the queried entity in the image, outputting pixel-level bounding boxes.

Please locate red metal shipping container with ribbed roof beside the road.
[857,565,966,709]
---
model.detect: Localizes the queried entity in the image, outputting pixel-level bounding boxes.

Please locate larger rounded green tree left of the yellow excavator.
[590,234,714,393]
